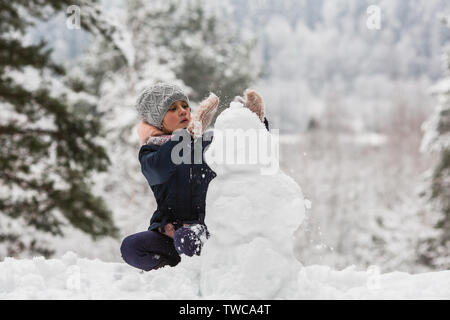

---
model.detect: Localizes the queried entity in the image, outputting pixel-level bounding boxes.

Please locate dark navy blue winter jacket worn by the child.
[139,129,216,230]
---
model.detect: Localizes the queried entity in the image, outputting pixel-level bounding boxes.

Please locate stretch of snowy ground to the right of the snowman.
[292,265,450,299]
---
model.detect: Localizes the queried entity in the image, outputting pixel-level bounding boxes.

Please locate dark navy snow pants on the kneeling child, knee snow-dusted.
[120,224,209,271]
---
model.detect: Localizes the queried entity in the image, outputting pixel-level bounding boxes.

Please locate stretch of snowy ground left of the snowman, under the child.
[0,252,199,299]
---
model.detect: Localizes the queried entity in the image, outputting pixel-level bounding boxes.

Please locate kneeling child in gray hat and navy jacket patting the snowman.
[120,83,268,271]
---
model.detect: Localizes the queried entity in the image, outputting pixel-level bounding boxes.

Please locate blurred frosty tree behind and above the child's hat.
[121,0,260,113]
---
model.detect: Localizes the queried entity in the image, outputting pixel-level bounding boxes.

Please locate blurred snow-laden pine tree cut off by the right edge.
[420,21,450,269]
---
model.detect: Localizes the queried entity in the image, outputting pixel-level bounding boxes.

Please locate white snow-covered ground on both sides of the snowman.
[0,251,450,300]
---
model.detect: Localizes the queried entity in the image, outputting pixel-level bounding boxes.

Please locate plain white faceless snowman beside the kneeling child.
[201,103,305,299]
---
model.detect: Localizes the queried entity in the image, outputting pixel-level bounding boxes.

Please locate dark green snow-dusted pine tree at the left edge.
[0,0,125,256]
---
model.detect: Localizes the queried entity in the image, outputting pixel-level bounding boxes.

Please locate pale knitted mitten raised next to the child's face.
[186,93,219,138]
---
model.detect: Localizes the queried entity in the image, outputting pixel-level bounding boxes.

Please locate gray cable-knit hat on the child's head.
[136,83,189,129]
